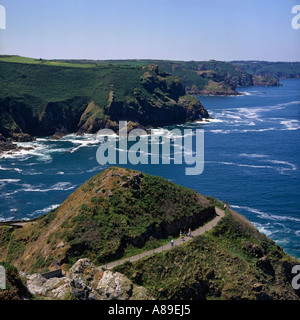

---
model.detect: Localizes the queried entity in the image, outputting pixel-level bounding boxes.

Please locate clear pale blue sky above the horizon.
[0,0,300,61]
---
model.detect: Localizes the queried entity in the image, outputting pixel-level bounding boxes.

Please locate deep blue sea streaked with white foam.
[0,80,300,258]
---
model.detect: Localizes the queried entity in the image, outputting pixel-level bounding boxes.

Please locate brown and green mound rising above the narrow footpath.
[0,167,215,272]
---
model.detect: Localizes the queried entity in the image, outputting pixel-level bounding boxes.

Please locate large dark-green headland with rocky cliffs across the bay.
[0,62,209,140]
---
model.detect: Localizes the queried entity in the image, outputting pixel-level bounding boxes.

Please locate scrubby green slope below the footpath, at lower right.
[115,210,300,300]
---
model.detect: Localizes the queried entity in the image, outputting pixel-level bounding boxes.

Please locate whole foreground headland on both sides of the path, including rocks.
[0,167,300,300]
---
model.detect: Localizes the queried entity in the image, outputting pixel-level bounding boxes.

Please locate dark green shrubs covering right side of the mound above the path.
[55,169,216,265]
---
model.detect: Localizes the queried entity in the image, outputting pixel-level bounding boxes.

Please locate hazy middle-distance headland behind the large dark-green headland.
[48,60,280,95]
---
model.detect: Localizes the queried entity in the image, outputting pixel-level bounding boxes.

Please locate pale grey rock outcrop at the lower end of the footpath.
[20,259,153,300]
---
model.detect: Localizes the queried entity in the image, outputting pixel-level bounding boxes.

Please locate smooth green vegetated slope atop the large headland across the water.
[0,60,143,107]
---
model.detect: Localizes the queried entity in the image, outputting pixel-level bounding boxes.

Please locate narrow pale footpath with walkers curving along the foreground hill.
[98,207,225,269]
